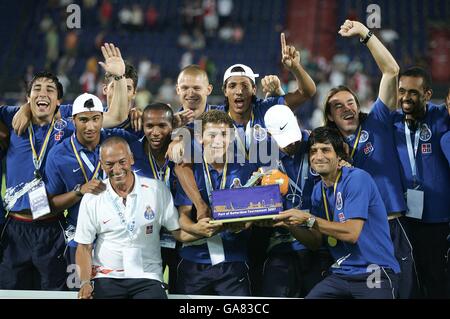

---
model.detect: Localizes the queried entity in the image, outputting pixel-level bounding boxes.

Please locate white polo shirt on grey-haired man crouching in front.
[75,174,180,282]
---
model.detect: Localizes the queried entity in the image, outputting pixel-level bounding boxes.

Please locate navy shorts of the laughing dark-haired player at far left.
[0,217,67,290]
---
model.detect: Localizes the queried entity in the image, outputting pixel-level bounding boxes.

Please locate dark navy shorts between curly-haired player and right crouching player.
[262,249,333,298]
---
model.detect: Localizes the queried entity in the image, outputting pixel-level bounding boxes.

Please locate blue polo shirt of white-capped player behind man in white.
[45,129,136,226]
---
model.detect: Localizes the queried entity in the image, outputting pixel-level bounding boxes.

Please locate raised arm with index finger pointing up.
[281,33,316,109]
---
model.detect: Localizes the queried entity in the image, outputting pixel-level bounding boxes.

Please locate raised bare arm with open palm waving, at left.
[99,43,129,128]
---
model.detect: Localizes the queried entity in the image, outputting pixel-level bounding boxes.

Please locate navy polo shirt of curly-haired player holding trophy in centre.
[175,159,258,264]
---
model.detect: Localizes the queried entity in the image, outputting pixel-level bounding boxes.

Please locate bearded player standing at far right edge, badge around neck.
[393,67,450,298]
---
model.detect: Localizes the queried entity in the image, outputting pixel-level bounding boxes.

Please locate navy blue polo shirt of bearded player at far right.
[392,104,450,223]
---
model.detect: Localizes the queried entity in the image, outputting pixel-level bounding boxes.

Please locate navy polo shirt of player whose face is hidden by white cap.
[269,130,320,252]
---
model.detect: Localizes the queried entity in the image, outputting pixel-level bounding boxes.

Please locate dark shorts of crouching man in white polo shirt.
[93,278,167,299]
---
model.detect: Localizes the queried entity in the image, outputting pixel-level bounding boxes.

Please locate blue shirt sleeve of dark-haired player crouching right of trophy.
[343,170,374,220]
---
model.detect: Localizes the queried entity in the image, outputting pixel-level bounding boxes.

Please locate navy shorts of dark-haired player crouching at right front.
[306,268,398,299]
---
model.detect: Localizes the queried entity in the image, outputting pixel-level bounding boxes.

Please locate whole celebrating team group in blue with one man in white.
[0,20,450,299]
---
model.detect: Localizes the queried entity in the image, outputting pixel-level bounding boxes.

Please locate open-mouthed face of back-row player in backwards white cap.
[224,76,256,115]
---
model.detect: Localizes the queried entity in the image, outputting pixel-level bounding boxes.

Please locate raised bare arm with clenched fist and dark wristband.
[339,20,400,111]
